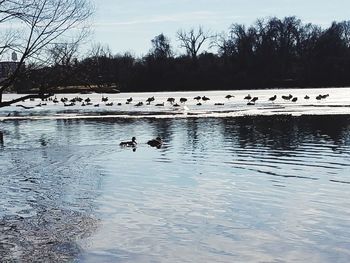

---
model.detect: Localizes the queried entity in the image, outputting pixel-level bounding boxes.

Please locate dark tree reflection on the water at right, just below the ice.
[221,116,350,155]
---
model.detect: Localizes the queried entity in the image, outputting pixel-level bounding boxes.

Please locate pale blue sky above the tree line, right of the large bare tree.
[92,0,350,56]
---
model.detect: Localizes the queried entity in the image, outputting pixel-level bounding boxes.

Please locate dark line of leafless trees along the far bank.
[5,13,350,98]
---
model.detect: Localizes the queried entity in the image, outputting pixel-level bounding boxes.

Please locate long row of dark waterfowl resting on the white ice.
[21,94,329,108]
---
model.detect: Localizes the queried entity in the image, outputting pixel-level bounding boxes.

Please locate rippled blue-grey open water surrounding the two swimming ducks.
[0,115,350,262]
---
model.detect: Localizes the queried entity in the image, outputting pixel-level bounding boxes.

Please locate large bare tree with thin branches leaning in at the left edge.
[0,0,92,107]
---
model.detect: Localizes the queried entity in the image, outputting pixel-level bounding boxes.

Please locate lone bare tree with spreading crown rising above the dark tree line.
[177,26,214,60]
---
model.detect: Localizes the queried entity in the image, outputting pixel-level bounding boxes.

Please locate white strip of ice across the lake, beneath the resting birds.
[0,88,350,121]
